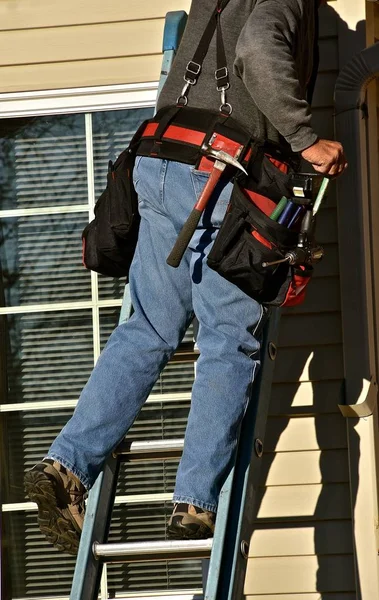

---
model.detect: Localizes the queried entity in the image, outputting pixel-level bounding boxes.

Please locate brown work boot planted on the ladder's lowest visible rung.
[167,503,216,540]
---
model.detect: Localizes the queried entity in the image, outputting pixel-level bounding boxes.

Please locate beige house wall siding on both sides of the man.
[0,0,363,600]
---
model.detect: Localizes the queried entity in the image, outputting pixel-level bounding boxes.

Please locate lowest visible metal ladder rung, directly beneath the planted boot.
[93,538,213,563]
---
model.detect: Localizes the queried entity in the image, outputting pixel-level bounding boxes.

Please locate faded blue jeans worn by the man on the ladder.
[48,157,264,512]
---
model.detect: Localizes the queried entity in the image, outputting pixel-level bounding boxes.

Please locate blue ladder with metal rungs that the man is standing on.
[70,11,280,600]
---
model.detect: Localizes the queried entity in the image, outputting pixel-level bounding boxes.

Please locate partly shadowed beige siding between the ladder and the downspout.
[245,5,356,600]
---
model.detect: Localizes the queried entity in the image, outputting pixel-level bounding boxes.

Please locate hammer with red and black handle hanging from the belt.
[166,144,247,268]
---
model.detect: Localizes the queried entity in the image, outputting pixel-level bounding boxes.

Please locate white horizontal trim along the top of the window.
[0,81,159,119]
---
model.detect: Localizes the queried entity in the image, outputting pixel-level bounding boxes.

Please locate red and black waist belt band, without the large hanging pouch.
[136,106,299,191]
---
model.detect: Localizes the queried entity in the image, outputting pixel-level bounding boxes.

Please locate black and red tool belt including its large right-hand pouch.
[137,106,313,306]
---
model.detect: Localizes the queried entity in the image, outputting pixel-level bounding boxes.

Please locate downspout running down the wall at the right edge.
[335,44,379,599]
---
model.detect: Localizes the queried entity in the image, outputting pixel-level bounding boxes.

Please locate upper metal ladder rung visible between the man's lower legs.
[114,439,184,461]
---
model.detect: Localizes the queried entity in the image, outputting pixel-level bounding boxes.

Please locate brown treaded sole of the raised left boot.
[24,471,80,556]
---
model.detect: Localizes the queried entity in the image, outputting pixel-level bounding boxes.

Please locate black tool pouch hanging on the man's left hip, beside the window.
[82,123,145,277]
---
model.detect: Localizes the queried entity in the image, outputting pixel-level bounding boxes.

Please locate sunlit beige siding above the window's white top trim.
[0,0,190,93]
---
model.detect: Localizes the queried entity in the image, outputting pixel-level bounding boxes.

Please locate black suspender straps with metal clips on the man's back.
[177,0,232,115]
